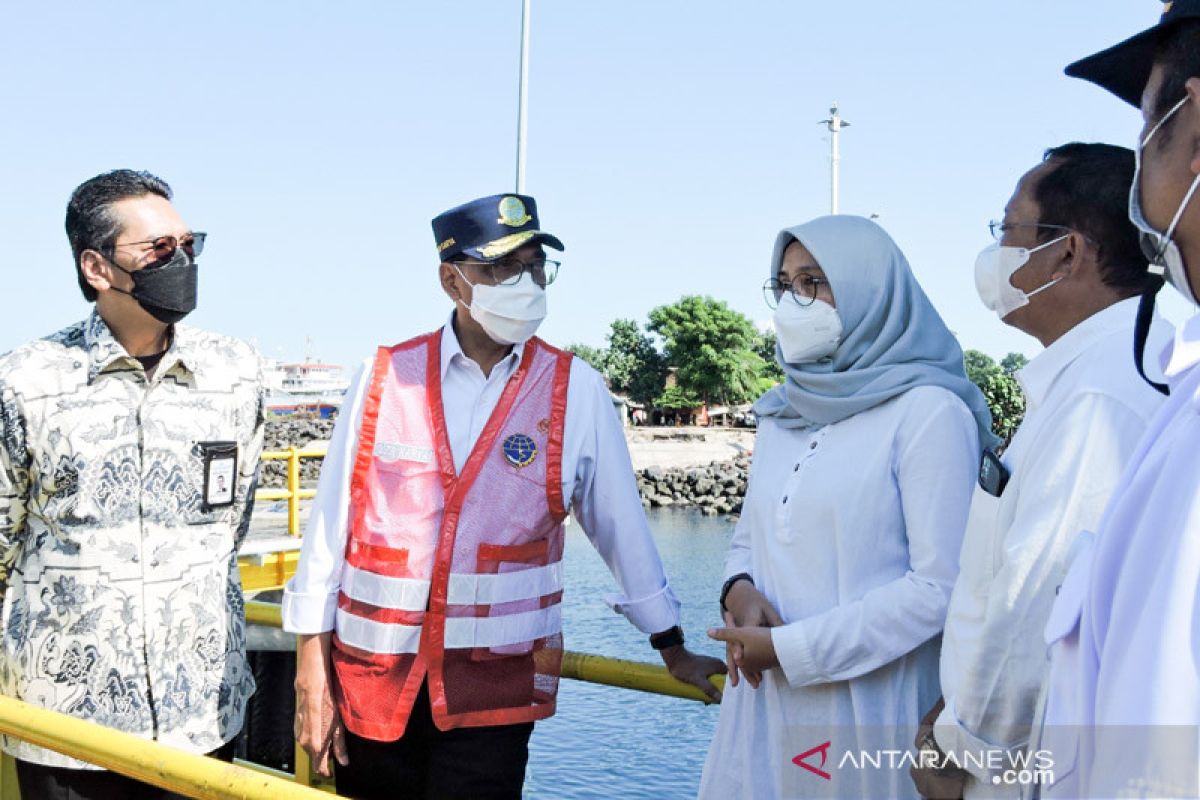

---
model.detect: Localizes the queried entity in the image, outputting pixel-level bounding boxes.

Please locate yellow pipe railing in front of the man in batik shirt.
[0,696,329,800]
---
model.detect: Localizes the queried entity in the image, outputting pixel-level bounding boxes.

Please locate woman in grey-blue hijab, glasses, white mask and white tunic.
[700,216,994,800]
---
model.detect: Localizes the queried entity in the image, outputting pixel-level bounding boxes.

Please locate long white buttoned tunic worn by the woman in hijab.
[700,386,979,800]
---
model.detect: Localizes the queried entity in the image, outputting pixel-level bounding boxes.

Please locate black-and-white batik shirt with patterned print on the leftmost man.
[0,313,264,768]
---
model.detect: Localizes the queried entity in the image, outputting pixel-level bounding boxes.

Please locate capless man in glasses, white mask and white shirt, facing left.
[914,143,1169,799]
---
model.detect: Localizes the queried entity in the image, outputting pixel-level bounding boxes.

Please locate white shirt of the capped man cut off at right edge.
[1042,315,1200,798]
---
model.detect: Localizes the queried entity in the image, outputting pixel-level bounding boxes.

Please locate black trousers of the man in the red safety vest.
[334,685,533,800]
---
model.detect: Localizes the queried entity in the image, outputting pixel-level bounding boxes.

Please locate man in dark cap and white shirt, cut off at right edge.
[1033,0,1200,798]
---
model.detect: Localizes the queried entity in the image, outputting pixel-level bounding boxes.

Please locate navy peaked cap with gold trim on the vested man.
[433,194,563,261]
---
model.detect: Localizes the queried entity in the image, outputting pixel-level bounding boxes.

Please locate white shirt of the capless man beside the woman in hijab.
[935,299,1170,800]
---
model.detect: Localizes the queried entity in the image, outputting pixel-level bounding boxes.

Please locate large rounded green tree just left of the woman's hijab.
[648,295,764,404]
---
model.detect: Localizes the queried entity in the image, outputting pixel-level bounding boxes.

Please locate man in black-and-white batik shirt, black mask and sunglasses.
[0,170,263,800]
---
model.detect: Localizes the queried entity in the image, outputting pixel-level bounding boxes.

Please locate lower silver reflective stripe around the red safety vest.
[337,603,563,654]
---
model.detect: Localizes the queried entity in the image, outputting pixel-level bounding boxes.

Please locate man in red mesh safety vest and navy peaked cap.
[283,194,724,798]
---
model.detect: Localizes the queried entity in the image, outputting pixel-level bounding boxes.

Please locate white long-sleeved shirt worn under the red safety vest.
[283,323,679,633]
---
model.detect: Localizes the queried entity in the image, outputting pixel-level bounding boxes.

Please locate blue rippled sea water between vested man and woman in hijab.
[524,509,733,800]
